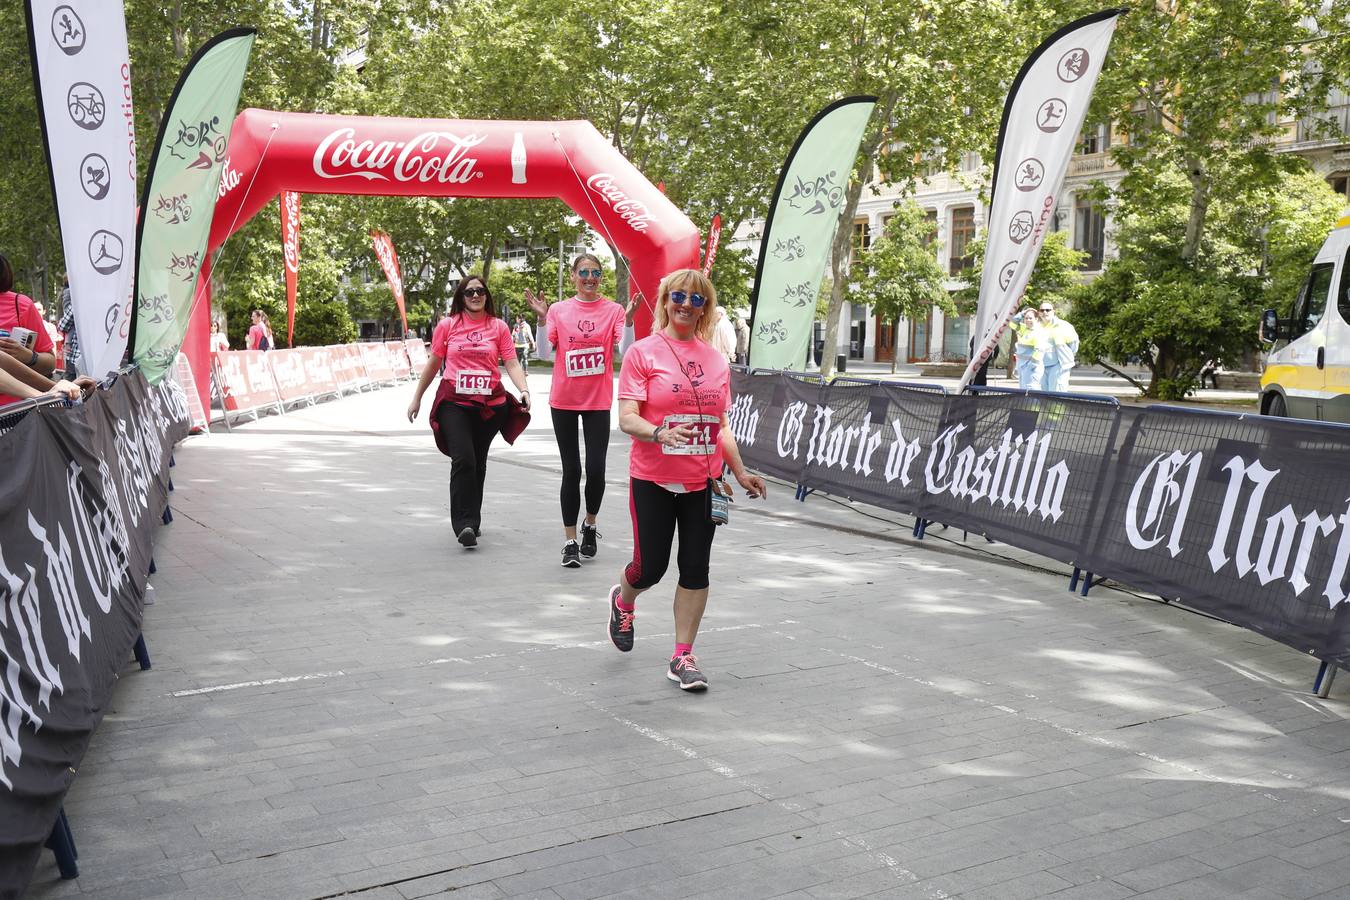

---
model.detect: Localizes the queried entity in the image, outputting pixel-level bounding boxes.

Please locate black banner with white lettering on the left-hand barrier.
[0,372,188,897]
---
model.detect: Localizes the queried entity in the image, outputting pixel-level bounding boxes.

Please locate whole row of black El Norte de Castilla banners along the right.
[730,372,1350,664]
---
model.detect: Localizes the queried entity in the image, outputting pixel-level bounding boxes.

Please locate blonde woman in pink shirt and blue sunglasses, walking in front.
[609,269,764,691]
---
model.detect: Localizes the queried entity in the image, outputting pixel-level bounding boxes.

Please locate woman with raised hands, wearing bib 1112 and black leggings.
[525,254,624,568]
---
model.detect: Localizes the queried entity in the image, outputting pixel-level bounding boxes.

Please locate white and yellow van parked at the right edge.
[1261,215,1350,422]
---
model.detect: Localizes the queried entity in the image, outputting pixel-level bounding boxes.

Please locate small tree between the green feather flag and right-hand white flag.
[842,201,956,374]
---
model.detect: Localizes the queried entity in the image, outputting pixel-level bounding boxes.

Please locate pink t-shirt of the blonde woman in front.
[618,335,732,491]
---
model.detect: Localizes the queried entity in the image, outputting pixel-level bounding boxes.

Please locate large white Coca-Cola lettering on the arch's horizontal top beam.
[315,128,487,185]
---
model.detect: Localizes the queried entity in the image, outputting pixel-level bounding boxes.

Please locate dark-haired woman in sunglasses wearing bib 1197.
[408,275,529,548]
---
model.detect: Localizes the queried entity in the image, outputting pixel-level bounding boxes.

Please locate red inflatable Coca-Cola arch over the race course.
[185,109,699,402]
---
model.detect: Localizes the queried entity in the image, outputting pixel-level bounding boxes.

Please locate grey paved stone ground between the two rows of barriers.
[30,375,1350,900]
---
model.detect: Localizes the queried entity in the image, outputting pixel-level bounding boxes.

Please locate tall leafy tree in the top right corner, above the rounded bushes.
[1096,0,1350,264]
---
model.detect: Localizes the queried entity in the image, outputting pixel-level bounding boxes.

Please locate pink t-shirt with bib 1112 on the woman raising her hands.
[545,297,624,410]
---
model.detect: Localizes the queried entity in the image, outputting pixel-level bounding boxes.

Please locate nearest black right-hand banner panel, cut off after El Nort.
[1083,406,1350,663]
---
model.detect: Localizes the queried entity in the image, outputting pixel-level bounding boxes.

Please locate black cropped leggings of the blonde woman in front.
[624,478,717,591]
